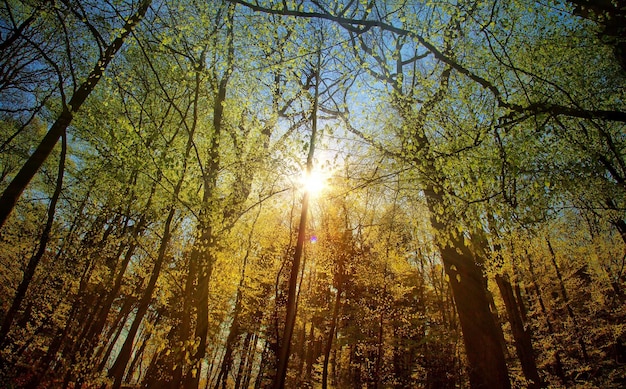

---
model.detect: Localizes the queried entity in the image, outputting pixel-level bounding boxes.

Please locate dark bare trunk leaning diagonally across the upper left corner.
[0,0,152,229]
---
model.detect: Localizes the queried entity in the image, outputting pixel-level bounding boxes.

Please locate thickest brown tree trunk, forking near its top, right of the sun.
[394,55,511,389]
